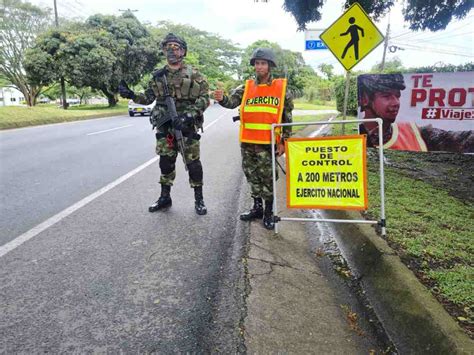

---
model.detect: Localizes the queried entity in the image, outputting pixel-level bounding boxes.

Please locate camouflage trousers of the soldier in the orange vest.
[240,143,278,201]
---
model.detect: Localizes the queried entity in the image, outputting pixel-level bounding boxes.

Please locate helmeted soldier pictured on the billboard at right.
[357,74,474,152]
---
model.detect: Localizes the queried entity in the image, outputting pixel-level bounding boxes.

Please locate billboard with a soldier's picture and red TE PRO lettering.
[357,72,474,153]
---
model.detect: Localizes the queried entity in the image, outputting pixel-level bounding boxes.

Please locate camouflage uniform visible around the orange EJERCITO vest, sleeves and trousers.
[219,75,294,200]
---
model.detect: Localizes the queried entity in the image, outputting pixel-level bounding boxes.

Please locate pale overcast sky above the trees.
[30,0,474,74]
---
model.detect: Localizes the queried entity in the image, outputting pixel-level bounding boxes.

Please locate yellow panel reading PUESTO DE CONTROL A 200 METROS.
[285,135,368,210]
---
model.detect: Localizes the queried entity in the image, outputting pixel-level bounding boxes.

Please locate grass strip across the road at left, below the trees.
[0,100,128,129]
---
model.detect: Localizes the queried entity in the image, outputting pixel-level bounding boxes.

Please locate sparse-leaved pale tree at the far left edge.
[0,0,52,106]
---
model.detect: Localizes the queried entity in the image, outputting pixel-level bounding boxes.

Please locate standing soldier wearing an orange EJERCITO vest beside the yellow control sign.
[214,48,293,229]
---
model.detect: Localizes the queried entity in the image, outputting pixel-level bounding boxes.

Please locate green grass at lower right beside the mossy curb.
[368,152,474,322]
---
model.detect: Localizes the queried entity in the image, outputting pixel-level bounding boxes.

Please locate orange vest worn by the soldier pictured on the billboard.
[383,123,428,152]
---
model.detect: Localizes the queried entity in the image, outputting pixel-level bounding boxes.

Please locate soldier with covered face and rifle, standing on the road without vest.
[119,33,209,215]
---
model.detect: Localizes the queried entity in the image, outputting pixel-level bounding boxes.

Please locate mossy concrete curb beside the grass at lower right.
[327,211,474,354]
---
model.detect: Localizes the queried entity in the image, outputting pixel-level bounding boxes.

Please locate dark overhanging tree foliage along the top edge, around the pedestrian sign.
[283,0,474,31]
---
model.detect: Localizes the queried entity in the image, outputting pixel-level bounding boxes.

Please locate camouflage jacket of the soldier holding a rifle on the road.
[134,64,209,133]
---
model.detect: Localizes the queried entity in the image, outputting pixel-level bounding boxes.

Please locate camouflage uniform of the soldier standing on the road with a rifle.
[134,64,209,188]
